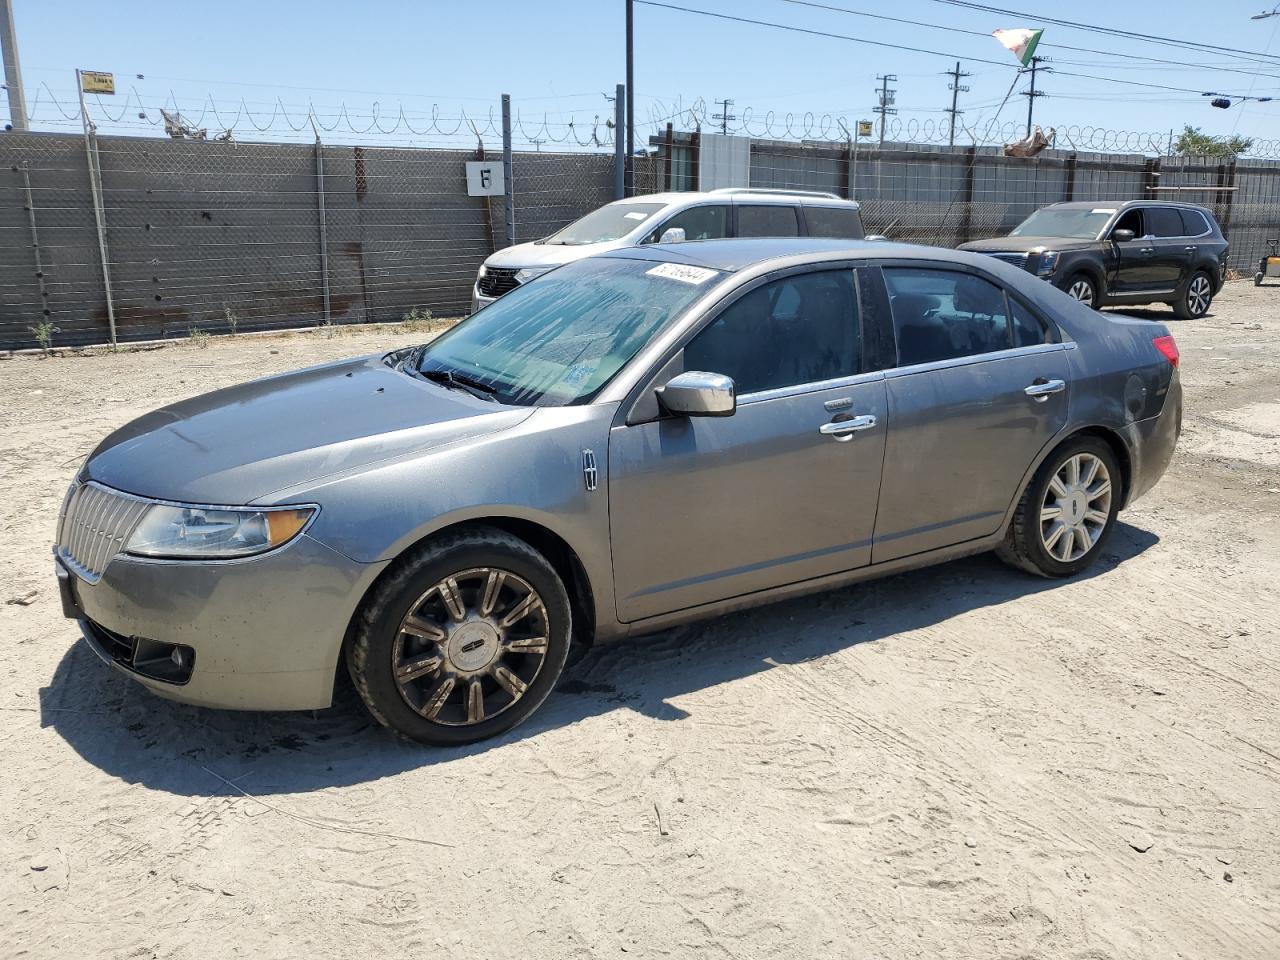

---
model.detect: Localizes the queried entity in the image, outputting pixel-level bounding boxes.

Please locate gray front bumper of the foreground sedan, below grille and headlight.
[55,534,387,710]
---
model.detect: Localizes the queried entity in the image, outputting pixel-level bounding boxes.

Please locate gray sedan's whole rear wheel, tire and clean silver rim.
[996,436,1124,577]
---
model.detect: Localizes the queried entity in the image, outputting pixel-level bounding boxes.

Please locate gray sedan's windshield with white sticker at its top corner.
[417,257,721,407]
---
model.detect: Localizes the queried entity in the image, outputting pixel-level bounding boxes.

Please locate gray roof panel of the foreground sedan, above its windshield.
[596,237,916,273]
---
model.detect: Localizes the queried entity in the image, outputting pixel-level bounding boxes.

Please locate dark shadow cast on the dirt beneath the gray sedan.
[40,524,1158,796]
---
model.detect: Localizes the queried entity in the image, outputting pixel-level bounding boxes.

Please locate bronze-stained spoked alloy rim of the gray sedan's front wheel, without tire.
[392,567,549,726]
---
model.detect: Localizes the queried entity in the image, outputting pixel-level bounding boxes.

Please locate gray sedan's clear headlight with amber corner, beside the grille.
[124,503,315,559]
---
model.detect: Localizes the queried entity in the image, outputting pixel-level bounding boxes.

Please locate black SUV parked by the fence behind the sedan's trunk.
[960,200,1228,320]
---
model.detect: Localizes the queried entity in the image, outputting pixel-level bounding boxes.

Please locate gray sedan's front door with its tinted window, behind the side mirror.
[609,264,887,622]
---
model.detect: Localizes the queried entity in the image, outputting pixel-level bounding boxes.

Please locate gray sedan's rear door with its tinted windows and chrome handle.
[872,261,1070,563]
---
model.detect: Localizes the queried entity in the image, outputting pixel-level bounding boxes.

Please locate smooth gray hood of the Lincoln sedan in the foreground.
[83,356,532,504]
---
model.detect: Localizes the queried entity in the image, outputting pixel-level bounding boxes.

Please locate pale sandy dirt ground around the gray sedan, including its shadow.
[0,291,1280,960]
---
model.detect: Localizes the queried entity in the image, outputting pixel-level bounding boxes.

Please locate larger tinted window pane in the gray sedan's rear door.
[884,268,1012,366]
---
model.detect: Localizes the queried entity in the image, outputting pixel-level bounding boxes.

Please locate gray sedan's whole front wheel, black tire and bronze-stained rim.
[347,526,572,746]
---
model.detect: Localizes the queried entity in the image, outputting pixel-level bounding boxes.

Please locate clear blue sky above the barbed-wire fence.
[13,0,1280,150]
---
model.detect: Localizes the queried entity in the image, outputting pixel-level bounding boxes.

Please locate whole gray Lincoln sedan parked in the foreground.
[55,239,1181,744]
